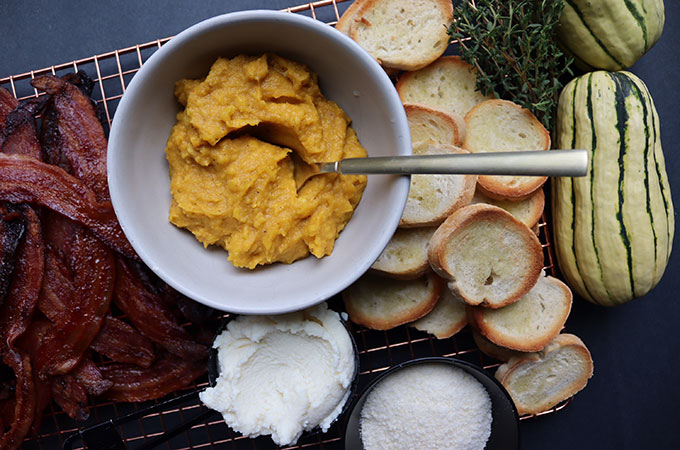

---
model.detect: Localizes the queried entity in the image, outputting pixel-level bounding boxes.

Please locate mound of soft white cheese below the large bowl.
[200,303,355,445]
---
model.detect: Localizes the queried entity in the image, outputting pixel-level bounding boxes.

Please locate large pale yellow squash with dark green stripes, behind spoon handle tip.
[552,71,675,306]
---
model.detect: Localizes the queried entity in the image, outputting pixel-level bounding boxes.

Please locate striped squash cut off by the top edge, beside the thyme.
[557,0,664,70]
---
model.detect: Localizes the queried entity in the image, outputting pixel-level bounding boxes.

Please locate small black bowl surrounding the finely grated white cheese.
[345,357,519,450]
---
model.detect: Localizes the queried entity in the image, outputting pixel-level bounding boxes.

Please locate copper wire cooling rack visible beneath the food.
[0,0,569,449]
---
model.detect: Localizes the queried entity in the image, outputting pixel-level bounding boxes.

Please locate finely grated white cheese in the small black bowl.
[361,363,491,450]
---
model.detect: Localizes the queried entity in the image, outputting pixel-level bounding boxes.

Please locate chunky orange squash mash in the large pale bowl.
[166,54,366,269]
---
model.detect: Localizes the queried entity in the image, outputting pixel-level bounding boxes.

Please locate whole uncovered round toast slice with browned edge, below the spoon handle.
[428,203,543,308]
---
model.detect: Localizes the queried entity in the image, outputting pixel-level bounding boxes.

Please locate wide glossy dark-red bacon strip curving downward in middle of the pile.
[35,227,115,379]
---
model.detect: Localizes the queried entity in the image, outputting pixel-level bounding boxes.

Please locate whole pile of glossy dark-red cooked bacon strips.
[0,73,217,449]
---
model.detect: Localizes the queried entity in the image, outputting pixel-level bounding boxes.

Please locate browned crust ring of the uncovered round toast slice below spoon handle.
[428,203,543,308]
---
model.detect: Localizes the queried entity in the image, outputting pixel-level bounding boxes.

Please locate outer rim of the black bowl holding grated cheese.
[342,356,521,450]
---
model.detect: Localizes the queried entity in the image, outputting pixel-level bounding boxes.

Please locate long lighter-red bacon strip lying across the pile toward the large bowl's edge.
[0,153,137,259]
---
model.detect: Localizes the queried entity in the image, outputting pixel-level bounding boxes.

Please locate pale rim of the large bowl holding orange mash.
[107,9,410,314]
